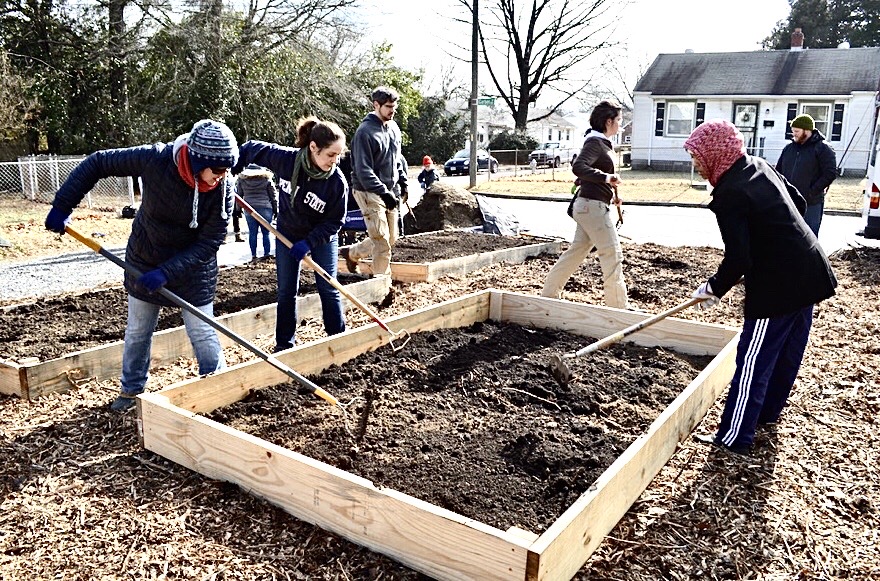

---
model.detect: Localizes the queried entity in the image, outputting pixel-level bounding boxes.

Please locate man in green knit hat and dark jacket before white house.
[776,115,837,236]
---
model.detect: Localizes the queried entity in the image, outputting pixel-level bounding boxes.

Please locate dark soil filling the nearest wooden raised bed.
[210,321,711,533]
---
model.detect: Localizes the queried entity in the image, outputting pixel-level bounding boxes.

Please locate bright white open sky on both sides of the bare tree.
[354,0,796,103]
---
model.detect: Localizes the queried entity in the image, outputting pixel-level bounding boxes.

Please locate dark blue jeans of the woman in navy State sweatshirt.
[275,236,345,351]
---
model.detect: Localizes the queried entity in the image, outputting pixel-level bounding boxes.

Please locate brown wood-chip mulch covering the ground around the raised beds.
[0,245,880,580]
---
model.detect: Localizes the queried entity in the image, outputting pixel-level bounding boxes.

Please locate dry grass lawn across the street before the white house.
[476,167,865,212]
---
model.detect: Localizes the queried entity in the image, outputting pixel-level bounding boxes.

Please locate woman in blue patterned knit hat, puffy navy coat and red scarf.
[46,119,238,411]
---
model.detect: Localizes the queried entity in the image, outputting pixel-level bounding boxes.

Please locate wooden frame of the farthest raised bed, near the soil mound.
[338,230,563,282]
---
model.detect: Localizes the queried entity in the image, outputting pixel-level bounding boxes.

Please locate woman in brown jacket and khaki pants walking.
[541,101,628,309]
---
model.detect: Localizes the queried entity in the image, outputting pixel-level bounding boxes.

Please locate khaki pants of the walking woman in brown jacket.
[541,198,627,309]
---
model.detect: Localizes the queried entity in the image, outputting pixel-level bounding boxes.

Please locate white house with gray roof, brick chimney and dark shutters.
[632,29,880,176]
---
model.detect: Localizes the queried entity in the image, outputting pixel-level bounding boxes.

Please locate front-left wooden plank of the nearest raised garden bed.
[139,393,528,580]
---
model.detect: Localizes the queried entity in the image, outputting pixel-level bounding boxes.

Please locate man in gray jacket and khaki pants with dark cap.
[339,87,408,274]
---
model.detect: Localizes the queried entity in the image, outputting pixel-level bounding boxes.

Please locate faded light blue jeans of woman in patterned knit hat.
[122,295,226,395]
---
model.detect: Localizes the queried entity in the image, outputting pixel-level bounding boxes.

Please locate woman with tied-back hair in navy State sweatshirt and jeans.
[239,117,348,352]
